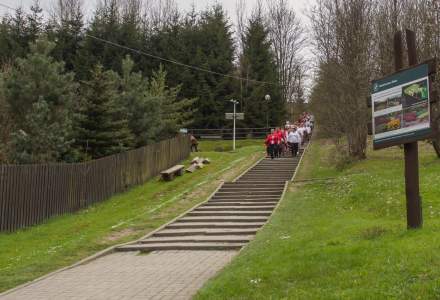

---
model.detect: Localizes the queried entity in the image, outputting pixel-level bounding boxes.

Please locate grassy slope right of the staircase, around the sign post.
[196,140,440,299]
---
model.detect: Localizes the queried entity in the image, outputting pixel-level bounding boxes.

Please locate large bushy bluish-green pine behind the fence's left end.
[3,39,77,163]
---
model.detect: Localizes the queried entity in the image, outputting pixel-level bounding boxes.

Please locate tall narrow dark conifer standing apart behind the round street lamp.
[240,11,285,127]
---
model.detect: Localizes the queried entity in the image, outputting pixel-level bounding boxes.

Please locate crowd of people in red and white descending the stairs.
[265,113,314,159]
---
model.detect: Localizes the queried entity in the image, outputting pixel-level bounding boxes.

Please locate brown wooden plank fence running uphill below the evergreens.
[0,135,190,232]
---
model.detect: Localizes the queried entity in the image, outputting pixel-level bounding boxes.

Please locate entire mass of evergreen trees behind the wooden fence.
[0,0,284,162]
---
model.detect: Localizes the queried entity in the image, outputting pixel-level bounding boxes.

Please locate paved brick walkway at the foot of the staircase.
[0,251,237,300]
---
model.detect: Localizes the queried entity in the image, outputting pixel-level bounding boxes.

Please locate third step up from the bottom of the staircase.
[153,228,258,237]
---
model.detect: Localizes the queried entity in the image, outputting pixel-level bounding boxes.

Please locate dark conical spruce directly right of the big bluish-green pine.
[78,65,133,159]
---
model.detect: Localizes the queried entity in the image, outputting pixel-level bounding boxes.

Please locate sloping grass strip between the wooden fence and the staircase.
[0,141,263,292]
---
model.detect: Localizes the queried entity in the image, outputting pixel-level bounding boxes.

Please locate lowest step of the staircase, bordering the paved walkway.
[116,243,246,252]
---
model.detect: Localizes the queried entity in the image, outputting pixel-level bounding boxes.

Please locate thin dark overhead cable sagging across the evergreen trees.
[0,3,276,85]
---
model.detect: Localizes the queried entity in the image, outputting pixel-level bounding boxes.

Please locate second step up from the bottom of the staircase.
[139,235,254,244]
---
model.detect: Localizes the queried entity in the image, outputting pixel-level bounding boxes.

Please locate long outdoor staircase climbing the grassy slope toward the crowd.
[116,150,303,252]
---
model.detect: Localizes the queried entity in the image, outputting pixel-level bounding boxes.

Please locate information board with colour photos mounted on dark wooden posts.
[371,64,432,149]
